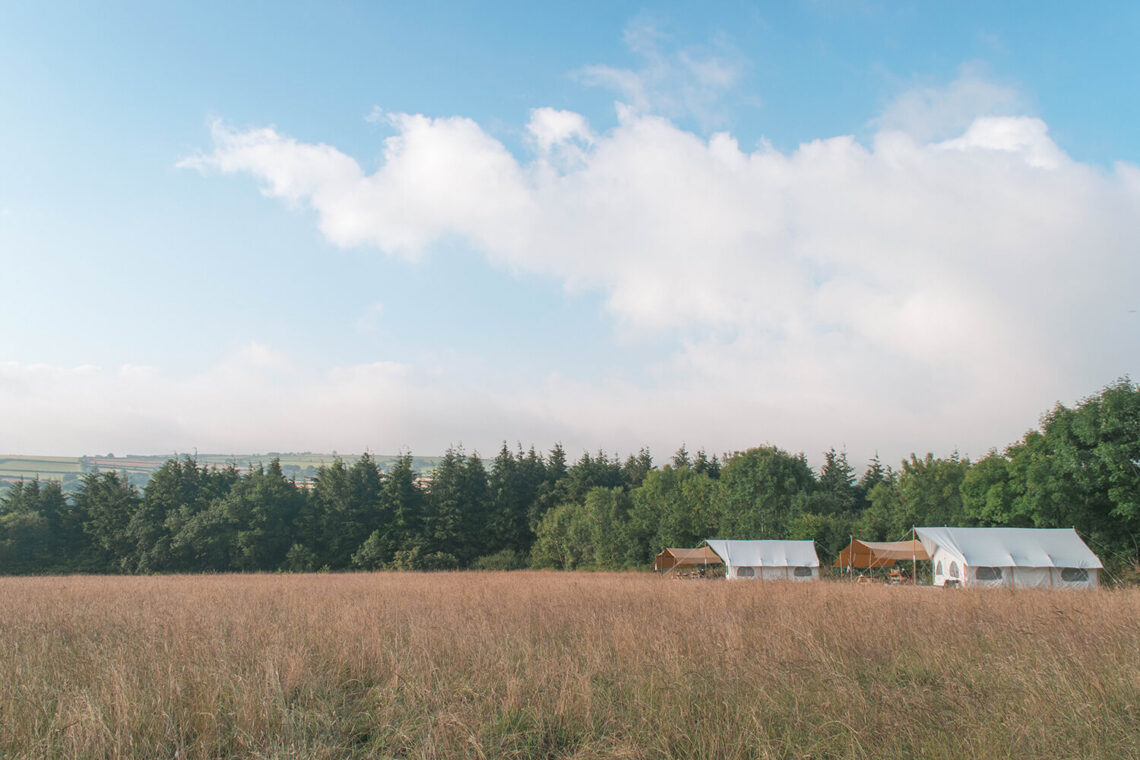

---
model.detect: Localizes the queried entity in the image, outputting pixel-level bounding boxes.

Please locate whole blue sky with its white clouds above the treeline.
[0,0,1140,466]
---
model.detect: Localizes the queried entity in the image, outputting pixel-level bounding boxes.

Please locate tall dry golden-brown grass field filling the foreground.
[0,573,1140,759]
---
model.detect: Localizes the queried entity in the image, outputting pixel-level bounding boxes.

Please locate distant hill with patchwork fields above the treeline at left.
[0,451,441,491]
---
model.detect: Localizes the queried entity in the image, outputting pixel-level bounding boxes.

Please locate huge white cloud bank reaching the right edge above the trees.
[166,74,1140,464]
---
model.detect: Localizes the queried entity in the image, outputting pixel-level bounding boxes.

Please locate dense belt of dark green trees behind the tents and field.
[0,378,1140,573]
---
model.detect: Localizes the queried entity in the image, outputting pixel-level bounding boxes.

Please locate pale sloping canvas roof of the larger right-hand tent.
[914,528,1104,570]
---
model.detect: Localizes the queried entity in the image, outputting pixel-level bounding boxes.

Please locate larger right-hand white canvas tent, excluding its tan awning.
[914,528,1104,588]
